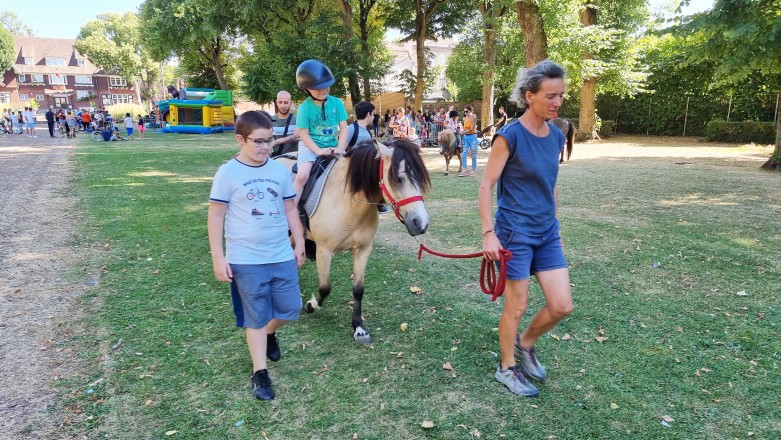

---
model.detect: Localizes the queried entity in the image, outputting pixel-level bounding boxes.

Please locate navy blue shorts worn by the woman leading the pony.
[495,220,567,280]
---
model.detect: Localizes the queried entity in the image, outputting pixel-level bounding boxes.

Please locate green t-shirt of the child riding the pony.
[296,95,347,148]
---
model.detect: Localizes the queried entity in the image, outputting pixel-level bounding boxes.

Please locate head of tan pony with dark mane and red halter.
[346,139,431,236]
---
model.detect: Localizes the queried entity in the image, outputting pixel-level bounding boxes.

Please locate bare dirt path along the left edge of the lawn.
[0,132,82,439]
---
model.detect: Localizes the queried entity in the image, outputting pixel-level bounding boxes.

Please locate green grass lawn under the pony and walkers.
[59,134,781,439]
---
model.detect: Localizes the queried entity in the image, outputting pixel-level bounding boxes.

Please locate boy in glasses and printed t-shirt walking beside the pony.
[208,111,304,400]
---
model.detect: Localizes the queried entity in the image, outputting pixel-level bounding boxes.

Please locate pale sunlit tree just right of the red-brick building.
[75,12,158,99]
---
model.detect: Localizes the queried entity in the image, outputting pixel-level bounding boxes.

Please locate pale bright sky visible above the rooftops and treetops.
[0,0,713,38]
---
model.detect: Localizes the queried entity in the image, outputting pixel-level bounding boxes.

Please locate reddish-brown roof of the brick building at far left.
[12,35,114,75]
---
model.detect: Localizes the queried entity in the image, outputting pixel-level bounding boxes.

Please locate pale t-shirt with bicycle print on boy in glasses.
[209,158,296,264]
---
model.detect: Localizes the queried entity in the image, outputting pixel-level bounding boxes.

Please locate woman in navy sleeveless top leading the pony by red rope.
[477,60,572,397]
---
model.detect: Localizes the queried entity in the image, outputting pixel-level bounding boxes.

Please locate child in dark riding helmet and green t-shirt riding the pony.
[293,60,347,205]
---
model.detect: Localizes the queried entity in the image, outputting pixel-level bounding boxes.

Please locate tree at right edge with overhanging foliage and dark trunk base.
[679,0,781,168]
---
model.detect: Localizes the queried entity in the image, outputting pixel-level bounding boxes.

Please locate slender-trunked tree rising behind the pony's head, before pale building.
[388,0,466,109]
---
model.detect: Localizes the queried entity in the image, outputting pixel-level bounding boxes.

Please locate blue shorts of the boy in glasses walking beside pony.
[231,260,302,329]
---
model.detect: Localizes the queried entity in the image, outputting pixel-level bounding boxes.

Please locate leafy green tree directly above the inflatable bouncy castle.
[141,0,238,89]
